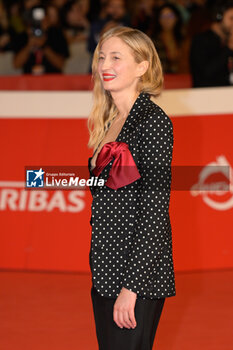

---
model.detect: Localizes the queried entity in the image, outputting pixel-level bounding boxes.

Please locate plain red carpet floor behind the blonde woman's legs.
[0,270,233,350]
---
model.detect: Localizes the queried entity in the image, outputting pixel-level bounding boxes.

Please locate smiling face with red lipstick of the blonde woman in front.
[98,37,140,92]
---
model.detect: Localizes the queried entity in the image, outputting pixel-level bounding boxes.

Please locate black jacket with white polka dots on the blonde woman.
[88,92,176,299]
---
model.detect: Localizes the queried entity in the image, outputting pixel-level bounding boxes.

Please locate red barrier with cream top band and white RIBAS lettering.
[0,82,233,272]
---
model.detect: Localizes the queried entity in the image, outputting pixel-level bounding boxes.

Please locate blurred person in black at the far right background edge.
[190,1,233,87]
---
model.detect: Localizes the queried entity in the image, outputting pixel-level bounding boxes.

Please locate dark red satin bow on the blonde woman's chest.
[92,141,141,190]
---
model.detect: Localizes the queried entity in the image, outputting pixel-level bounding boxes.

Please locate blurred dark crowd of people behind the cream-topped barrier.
[0,0,233,87]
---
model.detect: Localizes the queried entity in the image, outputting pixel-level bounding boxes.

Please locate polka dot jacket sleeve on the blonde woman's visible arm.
[122,106,173,295]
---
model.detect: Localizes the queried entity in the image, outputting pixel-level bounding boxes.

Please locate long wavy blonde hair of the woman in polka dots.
[87,26,163,149]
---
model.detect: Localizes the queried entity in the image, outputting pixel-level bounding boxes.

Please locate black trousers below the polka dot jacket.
[91,286,165,350]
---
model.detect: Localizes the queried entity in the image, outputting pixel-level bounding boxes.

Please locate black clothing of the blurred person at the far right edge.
[190,29,233,87]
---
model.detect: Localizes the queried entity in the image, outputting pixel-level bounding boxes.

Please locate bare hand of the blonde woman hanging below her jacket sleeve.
[113,287,137,328]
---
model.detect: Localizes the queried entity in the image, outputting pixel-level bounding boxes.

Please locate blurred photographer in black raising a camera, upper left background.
[13,7,69,74]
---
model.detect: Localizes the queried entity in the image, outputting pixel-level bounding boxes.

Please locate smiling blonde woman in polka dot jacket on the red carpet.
[88,27,176,350]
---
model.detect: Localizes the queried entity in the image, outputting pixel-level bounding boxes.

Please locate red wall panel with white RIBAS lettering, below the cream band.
[0,115,233,271]
